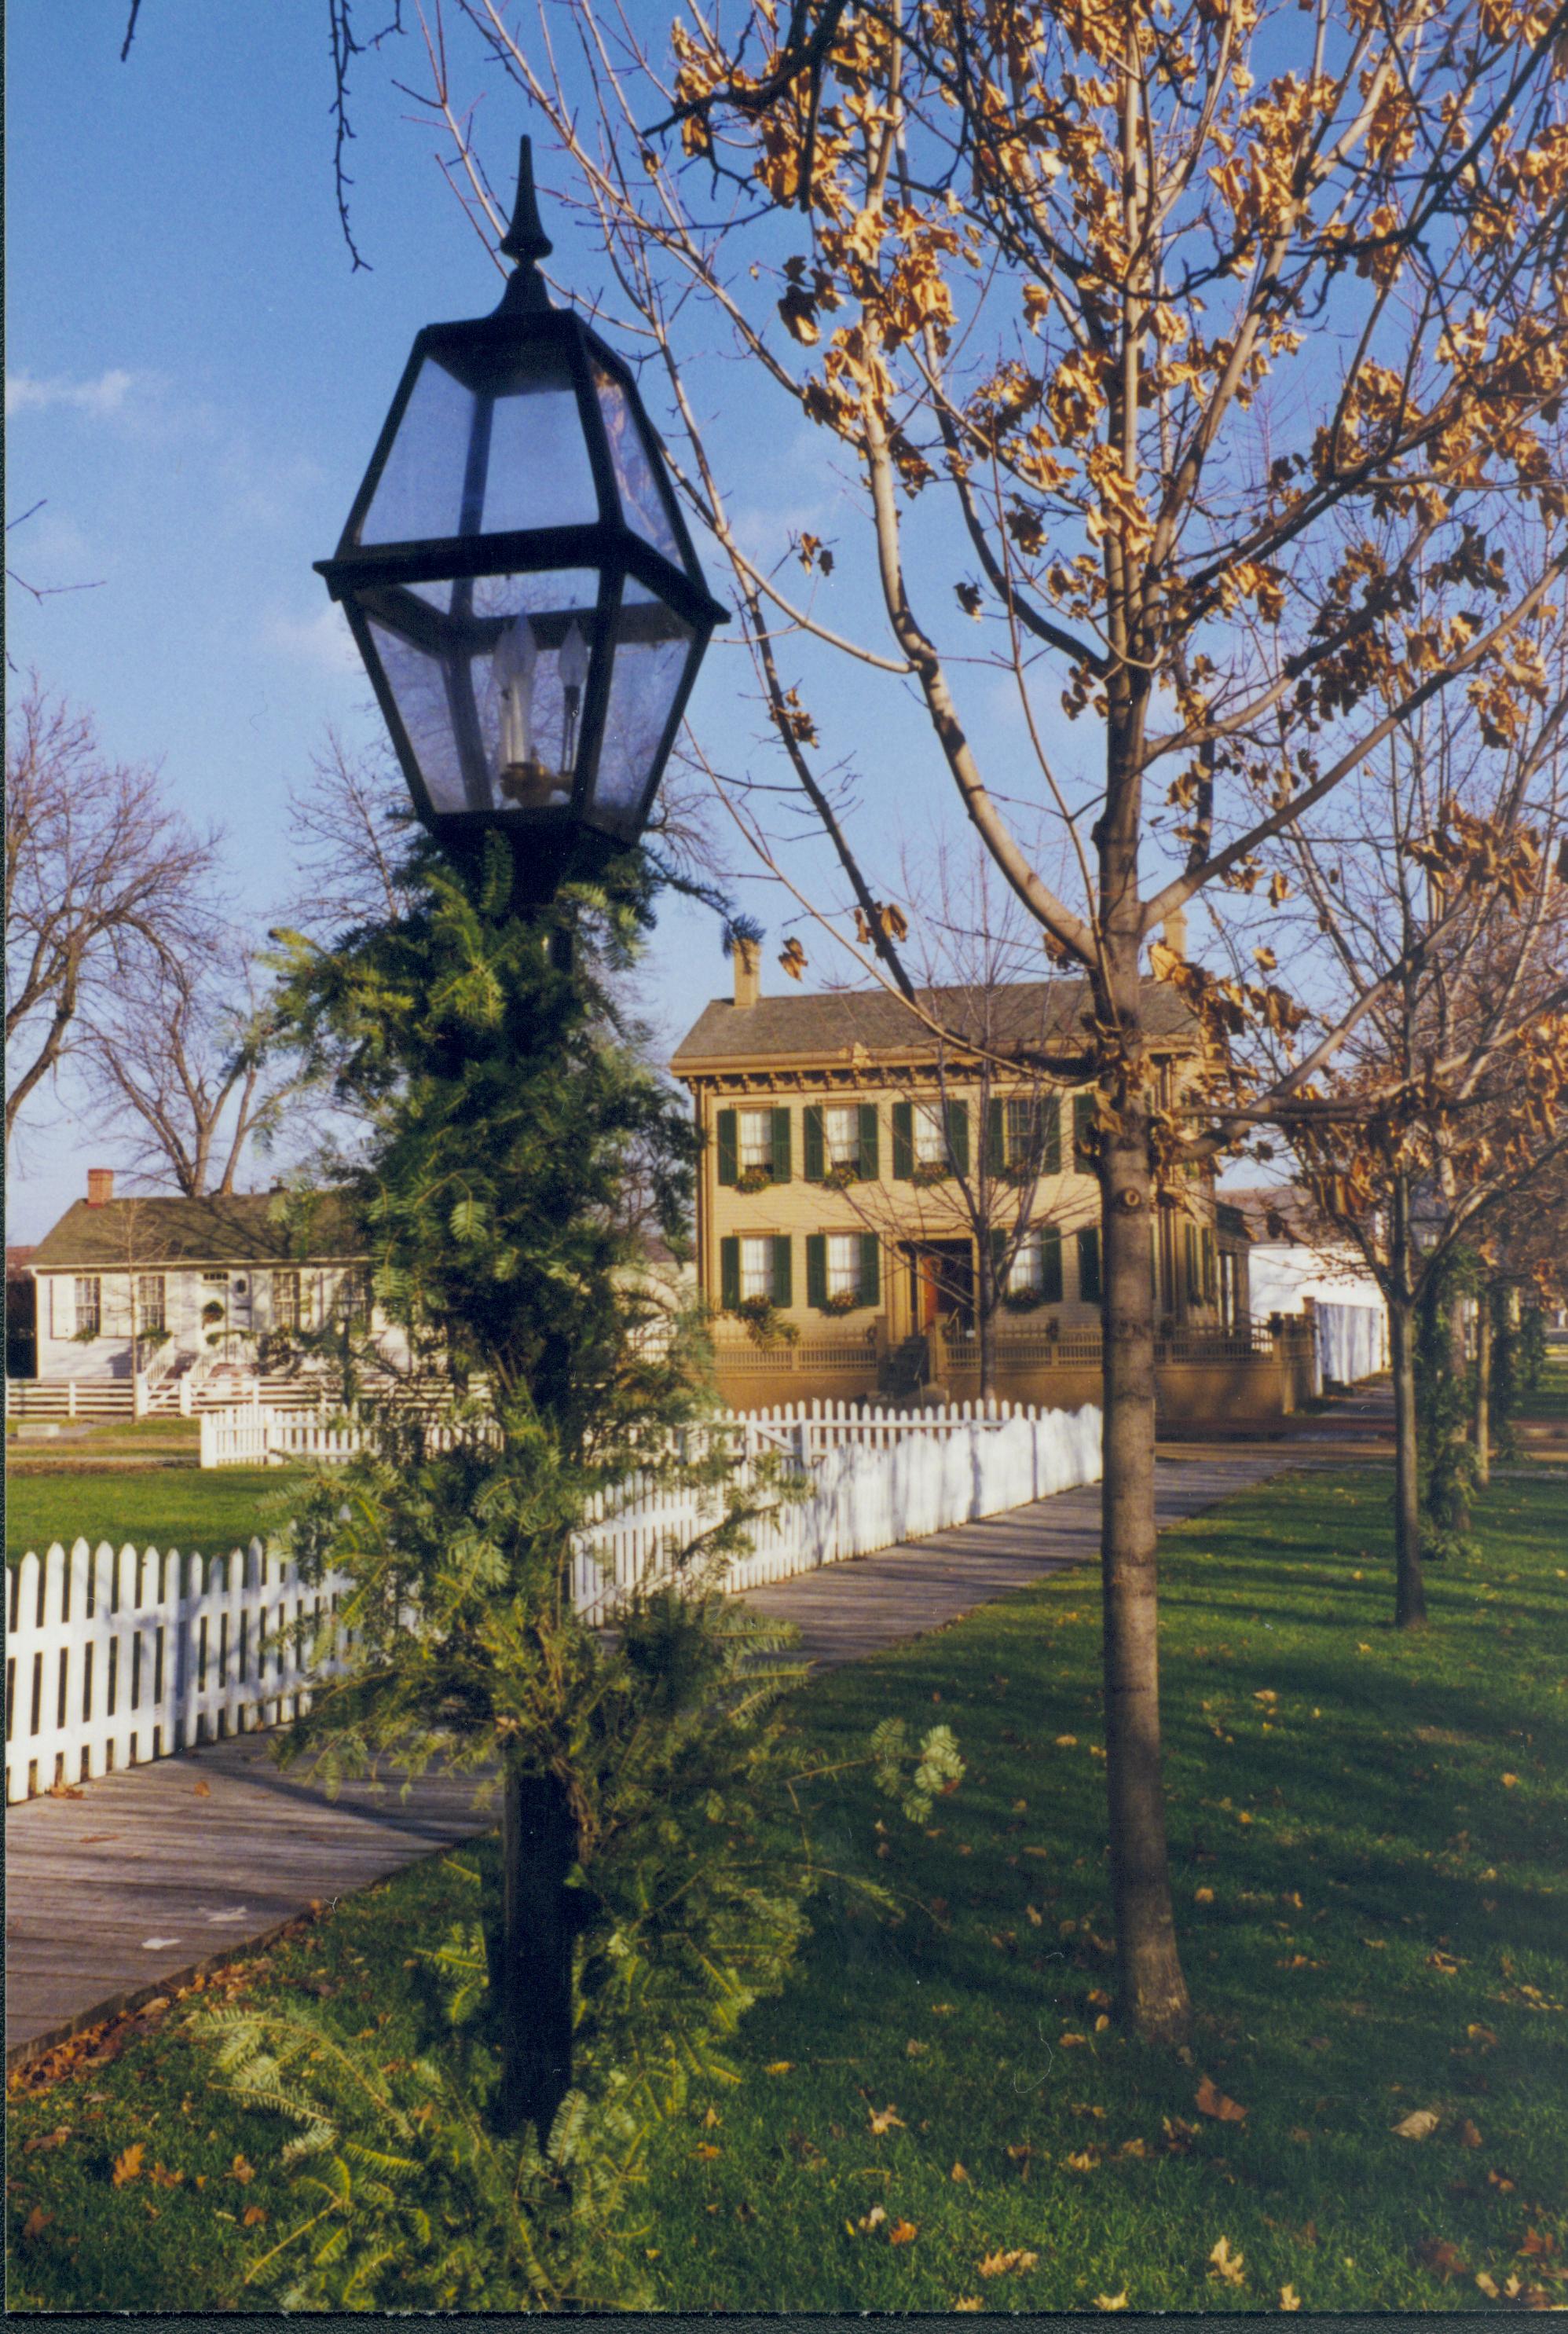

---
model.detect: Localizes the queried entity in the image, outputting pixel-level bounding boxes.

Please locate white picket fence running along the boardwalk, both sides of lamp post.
[5,1403,1101,1800]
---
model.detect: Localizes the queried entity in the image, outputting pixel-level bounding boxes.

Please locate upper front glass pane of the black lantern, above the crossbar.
[359,350,599,548]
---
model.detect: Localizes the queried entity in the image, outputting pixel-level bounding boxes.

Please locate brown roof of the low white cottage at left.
[31,1190,364,1272]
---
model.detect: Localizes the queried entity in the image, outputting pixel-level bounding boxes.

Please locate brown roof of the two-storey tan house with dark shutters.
[669,980,1197,1079]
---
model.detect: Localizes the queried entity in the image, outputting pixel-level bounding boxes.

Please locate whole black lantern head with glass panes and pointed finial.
[317,137,726,899]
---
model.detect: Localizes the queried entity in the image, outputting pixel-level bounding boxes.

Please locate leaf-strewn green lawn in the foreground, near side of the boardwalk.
[9,1471,1568,2310]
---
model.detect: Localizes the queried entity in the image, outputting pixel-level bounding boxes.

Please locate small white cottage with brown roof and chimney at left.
[28,1167,394,1408]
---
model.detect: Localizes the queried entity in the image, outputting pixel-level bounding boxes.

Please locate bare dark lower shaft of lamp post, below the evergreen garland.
[490,1767,577,2147]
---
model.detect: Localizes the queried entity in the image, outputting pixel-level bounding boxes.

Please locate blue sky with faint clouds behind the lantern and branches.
[7,0,1115,1240]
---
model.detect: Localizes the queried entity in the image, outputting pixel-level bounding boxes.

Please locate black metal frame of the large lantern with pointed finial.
[315,137,728,882]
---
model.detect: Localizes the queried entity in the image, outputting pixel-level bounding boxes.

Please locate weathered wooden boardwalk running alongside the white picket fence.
[5,1445,1297,2063]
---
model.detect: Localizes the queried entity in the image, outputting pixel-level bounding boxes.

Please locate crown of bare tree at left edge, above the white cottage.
[5,677,217,1151]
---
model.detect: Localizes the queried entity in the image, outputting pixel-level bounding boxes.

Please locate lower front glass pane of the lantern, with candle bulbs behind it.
[371,567,599,815]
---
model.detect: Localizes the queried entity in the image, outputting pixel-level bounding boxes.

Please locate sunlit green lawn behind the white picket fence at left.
[5,1466,296,1564]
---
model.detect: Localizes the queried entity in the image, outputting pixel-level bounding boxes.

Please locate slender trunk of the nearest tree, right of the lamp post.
[1101,1086,1192,2043]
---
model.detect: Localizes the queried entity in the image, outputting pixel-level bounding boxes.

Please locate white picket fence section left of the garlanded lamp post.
[5,1541,354,1800]
